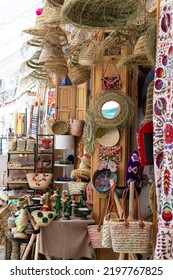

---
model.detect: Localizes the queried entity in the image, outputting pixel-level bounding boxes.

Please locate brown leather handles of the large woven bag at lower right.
[122,188,144,227]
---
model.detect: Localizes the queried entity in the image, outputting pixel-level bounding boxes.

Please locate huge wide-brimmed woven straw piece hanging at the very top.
[61,0,145,27]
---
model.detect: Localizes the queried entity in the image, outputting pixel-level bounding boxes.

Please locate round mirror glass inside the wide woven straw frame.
[101,101,121,119]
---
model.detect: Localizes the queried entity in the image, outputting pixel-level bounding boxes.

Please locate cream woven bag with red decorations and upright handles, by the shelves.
[26,160,53,191]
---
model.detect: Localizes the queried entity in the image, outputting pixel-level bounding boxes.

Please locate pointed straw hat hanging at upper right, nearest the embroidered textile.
[117,34,153,68]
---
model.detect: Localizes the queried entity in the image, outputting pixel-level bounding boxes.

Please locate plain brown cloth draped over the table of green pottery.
[39,216,95,259]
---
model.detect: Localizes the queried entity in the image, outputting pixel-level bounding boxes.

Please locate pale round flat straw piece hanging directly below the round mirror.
[97,129,120,147]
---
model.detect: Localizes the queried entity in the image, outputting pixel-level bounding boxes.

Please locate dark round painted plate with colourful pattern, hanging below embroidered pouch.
[92,169,118,193]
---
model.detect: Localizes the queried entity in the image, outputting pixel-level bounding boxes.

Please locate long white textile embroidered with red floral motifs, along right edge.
[153,0,173,260]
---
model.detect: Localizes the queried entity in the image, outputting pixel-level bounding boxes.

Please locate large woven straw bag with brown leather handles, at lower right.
[110,188,153,254]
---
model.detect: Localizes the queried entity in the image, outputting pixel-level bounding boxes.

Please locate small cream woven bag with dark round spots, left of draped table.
[31,210,57,227]
